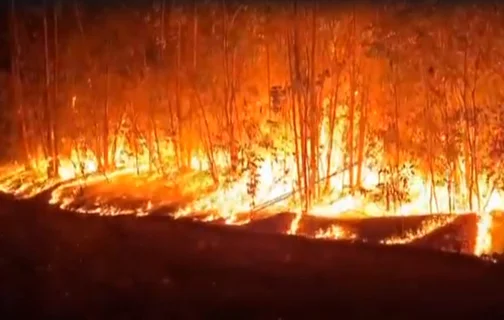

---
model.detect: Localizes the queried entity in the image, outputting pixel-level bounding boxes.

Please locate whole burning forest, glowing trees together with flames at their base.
[0,0,504,255]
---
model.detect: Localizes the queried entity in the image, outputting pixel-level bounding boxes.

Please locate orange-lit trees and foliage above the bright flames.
[3,1,504,210]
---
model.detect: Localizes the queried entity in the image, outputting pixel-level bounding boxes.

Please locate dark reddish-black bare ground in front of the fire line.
[0,191,504,319]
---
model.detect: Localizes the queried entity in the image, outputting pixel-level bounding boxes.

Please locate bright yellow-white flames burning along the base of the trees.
[0,102,498,255]
